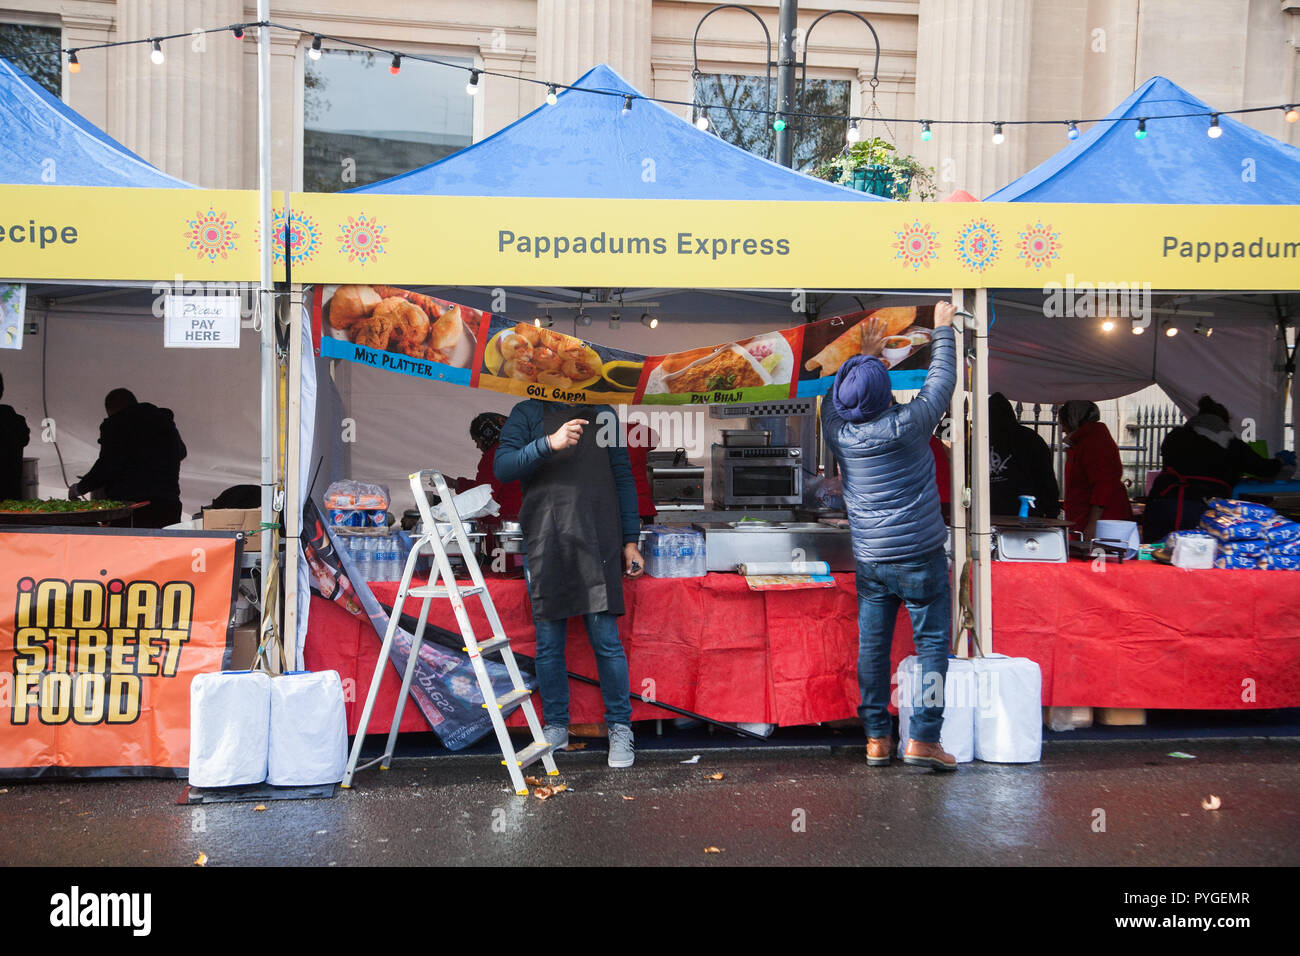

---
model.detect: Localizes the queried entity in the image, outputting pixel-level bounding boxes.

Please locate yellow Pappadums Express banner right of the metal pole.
[293,194,1300,290]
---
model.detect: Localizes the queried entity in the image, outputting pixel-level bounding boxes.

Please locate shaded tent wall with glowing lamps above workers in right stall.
[989,295,1286,449]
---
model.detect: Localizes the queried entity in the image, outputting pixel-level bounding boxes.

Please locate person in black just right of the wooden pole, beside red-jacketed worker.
[988,392,1061,518]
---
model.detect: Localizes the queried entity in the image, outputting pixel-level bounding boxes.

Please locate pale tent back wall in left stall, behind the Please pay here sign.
[0,300,259,515]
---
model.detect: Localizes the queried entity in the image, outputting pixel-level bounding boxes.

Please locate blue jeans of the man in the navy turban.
[858,549,953,744]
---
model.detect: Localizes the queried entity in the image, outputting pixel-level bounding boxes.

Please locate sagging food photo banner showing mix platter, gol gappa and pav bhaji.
[312,285,935,405]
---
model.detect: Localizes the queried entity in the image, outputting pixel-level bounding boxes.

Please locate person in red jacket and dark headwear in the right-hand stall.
[1058,401,1134,541]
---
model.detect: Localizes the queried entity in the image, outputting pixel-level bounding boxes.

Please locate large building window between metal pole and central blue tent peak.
[303,49,475,193]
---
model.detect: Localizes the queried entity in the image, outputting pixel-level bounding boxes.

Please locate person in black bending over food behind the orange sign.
[68,389,187,528]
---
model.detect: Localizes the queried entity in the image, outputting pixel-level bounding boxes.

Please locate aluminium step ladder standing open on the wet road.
[342,470,559,796]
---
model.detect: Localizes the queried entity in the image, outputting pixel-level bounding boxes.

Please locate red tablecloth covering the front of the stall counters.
[304,562,1300,732]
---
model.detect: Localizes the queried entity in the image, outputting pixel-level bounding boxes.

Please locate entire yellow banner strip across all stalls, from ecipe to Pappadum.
[0,186,1300,290]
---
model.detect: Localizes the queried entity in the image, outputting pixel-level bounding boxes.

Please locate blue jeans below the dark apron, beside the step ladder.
[533,611,632,727]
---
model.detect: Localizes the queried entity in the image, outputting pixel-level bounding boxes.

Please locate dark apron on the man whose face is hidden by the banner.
[519,402,624,620]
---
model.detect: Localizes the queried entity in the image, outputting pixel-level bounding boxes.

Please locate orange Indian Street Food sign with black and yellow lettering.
[0,528,243,777]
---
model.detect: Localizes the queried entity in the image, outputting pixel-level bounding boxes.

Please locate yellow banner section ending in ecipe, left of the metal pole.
[0,186,260,282]
